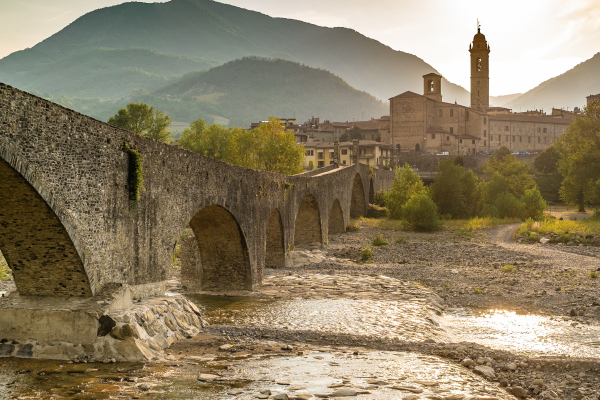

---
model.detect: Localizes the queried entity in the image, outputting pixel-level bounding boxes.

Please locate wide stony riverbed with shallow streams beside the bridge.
[0,223,600,400]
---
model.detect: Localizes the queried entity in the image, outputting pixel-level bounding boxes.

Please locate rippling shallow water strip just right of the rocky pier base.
[188,296,447,342]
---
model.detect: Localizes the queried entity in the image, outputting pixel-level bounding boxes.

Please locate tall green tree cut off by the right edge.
[555,101,600,212]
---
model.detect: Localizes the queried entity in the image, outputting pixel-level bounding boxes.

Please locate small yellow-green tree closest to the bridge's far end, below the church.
[385,164,426,219]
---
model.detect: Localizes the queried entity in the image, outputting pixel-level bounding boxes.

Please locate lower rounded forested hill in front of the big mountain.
[53,57,389,127]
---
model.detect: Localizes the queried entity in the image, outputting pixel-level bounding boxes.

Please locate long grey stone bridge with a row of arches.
[0,84,393,297]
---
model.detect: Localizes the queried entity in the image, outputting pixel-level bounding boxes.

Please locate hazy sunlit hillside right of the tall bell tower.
[504,53,600,112]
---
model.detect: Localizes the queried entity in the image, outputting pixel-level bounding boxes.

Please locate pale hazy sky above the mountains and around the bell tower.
[0,0,600,96]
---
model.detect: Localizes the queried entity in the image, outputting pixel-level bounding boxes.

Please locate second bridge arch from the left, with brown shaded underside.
[190,205,252,291]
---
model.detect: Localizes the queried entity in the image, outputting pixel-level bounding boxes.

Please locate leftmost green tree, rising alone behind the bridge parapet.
[108,103,171,142]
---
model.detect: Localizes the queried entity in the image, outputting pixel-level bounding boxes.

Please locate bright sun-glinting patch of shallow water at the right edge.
[441,308,600,358]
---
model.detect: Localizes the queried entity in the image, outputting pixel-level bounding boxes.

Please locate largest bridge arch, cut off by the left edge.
[0,156,95,296]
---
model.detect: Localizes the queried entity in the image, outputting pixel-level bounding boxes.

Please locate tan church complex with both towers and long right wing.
[382,28,577,155]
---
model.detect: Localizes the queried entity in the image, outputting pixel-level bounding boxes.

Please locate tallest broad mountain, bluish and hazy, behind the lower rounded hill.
[0,0,469,104]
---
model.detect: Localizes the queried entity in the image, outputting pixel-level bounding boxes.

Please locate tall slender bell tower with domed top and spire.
[469,23,490,112]
